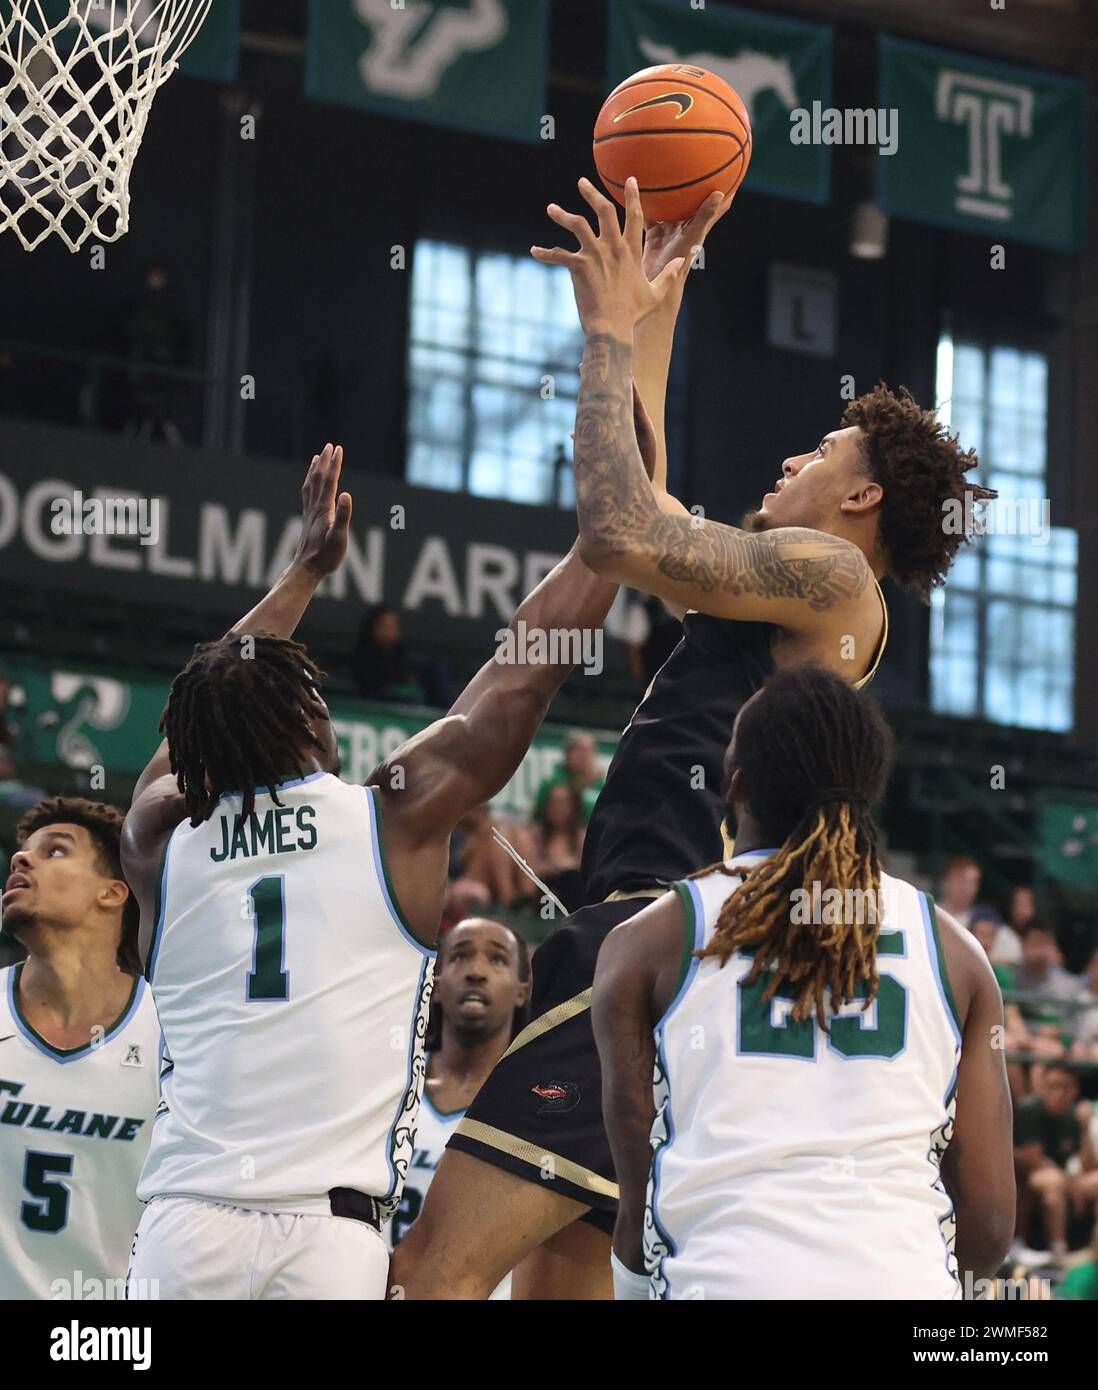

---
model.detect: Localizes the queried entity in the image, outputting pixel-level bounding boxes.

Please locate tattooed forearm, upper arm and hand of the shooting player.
[534,179,880,631]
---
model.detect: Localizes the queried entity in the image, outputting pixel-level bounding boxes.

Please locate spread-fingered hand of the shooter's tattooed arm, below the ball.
[531,178,691,339]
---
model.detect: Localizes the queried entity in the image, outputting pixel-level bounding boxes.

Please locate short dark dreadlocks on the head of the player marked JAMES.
[160,632,328,826]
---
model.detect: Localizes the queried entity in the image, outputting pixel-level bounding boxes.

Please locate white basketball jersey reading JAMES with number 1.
[139,773,435,1215]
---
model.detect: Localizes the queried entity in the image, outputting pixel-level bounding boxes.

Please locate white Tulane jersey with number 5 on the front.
[0,965,160,1301]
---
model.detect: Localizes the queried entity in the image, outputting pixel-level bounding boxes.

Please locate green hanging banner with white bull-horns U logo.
[306,0,549,140]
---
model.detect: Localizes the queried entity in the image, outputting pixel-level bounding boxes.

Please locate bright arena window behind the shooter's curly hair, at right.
[930,335,1079,733]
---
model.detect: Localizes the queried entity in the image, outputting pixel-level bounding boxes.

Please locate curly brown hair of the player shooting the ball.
[842,382,998,602]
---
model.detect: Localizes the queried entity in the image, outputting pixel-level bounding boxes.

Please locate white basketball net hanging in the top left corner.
[0,0,213,252]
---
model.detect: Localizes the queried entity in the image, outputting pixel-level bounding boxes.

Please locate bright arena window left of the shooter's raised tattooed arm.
[407,240,582,507]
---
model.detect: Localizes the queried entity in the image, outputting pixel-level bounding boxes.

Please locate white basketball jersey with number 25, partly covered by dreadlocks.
[645,855,960,1298]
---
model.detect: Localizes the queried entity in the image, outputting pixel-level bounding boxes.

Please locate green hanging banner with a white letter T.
[877,39,1085,252]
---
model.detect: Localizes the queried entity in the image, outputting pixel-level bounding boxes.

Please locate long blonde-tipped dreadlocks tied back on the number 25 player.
[698,666,892,1029]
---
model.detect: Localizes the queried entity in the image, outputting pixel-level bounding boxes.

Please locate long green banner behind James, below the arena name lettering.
[0,656,617,816]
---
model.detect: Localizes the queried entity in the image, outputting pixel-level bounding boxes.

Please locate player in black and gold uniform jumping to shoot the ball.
[395,179,994,1298]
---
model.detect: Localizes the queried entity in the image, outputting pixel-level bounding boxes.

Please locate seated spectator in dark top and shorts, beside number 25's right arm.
[1015,1062,1098,1264]
